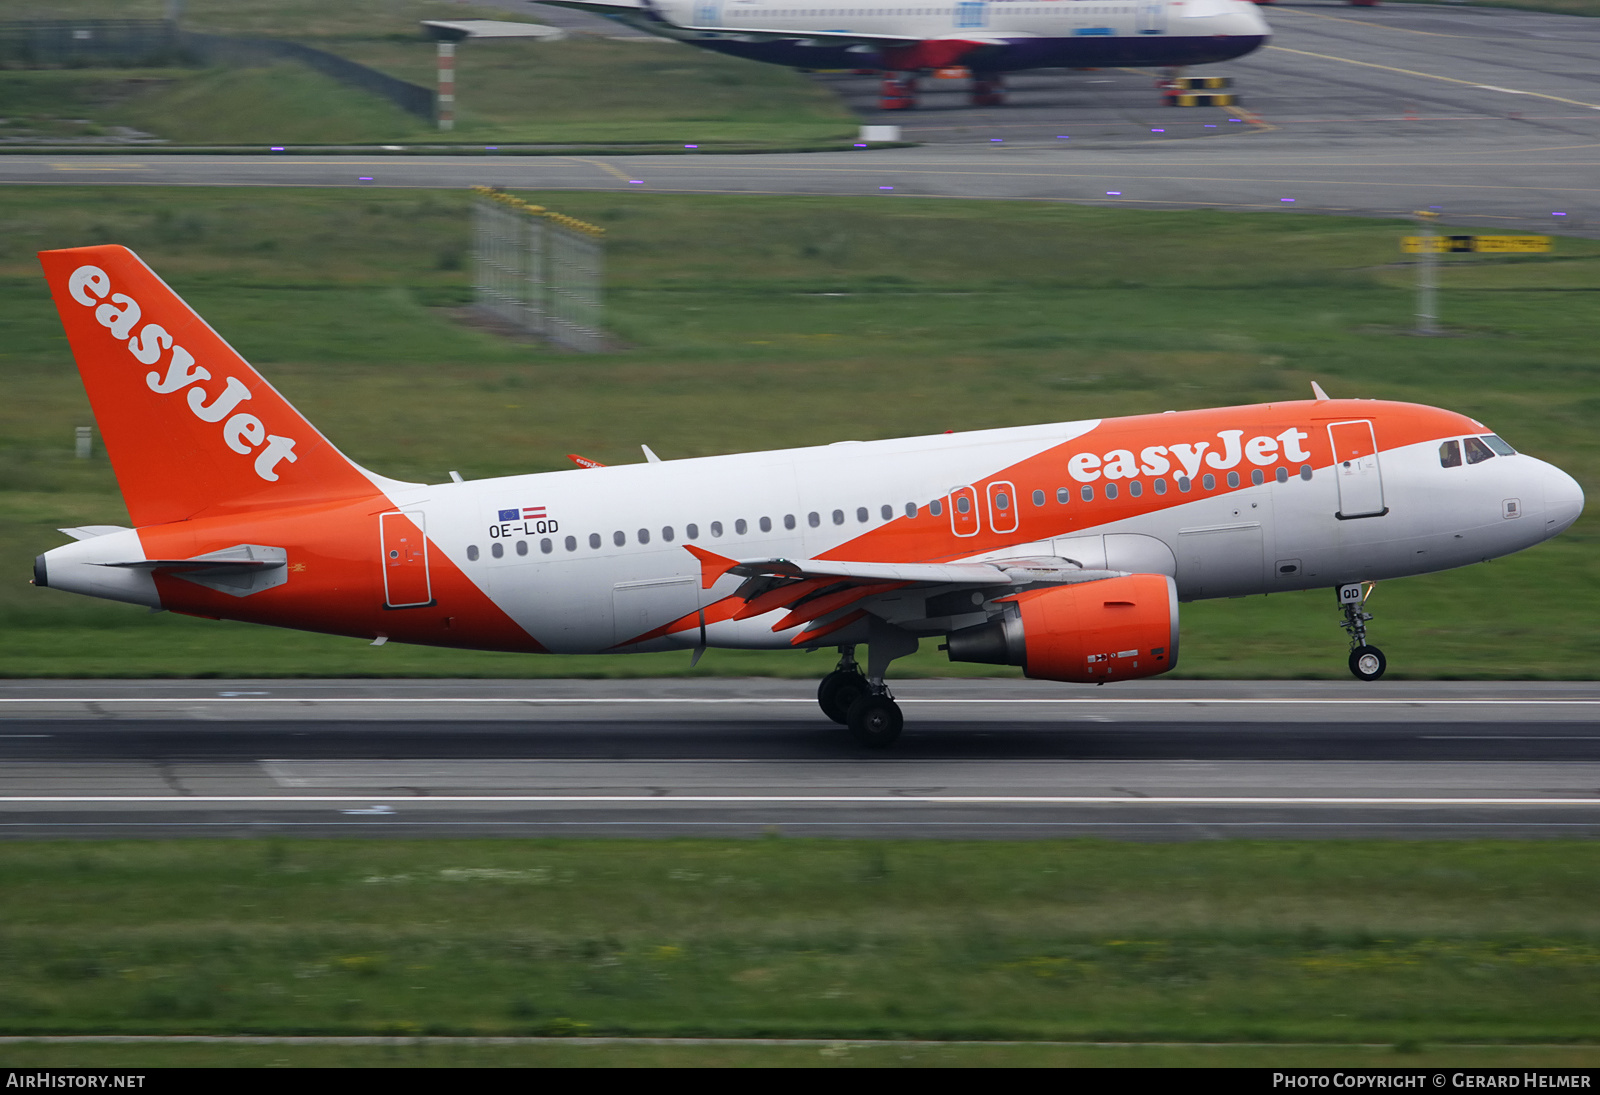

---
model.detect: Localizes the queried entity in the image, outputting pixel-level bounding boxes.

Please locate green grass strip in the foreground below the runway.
[0,839,1600,1043]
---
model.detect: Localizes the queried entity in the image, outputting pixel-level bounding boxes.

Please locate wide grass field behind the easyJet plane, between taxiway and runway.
[0,187,1600,679]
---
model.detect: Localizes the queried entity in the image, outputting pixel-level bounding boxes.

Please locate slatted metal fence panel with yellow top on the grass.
[474,186,605,354]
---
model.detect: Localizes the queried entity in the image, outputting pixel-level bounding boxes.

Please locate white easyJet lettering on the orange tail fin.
[67,266,299,483]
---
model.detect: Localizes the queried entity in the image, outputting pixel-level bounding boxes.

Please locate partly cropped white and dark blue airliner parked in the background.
[541,0,1270,109]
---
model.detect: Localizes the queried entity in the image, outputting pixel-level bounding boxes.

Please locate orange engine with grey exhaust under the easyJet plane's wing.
[946,575,1178,684]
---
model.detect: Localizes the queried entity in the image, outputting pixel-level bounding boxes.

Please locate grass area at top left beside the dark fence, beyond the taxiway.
[0,0,854,150]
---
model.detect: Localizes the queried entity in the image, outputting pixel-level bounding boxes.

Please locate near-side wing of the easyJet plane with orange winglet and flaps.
[685,544,1123,647]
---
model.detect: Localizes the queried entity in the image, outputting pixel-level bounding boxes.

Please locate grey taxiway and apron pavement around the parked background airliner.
[0,5,1600,235]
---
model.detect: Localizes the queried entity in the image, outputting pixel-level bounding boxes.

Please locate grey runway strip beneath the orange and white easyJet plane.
[0,680,1600,840]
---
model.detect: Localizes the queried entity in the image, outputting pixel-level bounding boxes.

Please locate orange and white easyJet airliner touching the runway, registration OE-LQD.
[34,247,1584,746]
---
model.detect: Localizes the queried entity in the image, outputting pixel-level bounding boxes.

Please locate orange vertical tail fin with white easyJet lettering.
[38,245,374,525]
